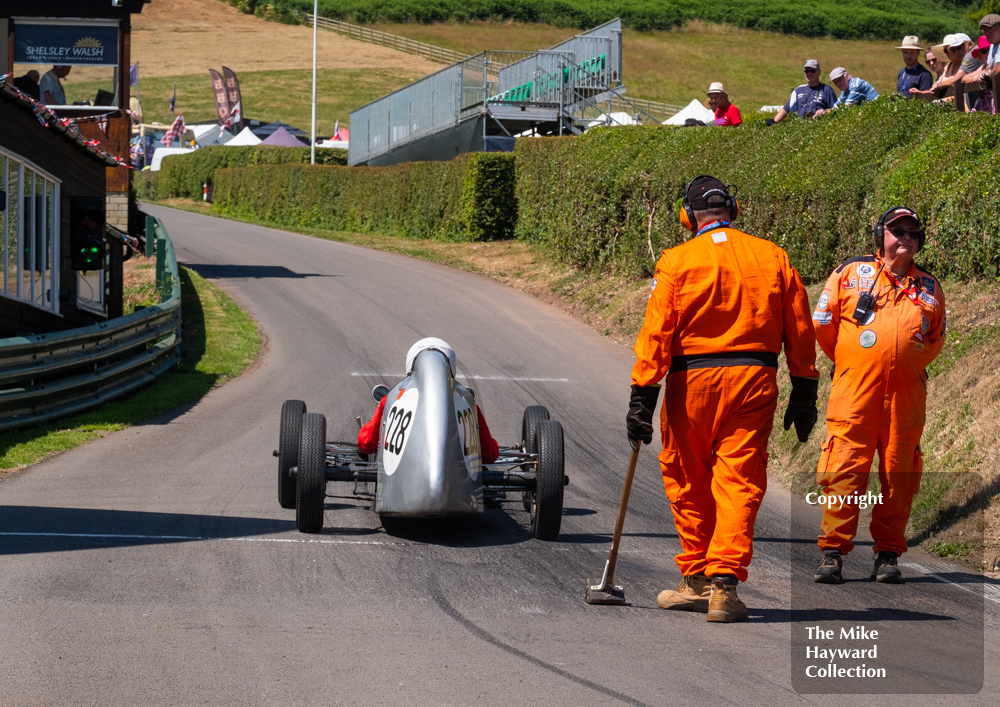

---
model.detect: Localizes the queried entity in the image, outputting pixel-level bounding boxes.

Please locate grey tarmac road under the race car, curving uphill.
[0,208,1000,705]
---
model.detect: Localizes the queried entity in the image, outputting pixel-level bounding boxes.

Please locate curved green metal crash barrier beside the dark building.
[0,216,181,432]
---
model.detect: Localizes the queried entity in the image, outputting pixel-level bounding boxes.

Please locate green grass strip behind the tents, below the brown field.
[66,67,422,136]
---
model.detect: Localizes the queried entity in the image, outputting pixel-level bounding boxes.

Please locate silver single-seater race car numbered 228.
[274,350,569,540]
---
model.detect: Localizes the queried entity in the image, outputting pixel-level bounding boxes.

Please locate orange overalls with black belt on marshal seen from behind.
[632,227,819,582]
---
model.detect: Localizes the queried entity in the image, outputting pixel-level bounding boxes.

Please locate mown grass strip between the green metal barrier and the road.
[0,268,260,475]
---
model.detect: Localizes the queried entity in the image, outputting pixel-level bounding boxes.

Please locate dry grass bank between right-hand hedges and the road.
[152,199,1000,571]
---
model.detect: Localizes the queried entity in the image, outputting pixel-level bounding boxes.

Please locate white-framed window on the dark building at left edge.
[0,150,59,314]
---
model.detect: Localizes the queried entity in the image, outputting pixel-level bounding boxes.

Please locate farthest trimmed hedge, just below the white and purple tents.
[156,145,347,199]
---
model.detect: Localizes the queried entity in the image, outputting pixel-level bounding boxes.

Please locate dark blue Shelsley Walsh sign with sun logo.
[14,21,118,66]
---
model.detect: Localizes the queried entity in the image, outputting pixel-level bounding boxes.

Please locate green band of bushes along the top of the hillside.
[229,0,975,40]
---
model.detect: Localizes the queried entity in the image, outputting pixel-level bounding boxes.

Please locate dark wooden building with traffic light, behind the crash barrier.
[0,0,150,338]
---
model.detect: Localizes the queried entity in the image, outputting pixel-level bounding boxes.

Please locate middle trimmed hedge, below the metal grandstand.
[212,153,517,241]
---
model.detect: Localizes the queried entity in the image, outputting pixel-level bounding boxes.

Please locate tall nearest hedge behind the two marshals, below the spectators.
[515,98,1000,281]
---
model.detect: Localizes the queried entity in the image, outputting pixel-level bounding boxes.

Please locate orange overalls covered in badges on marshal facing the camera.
[813,255,945,555]
